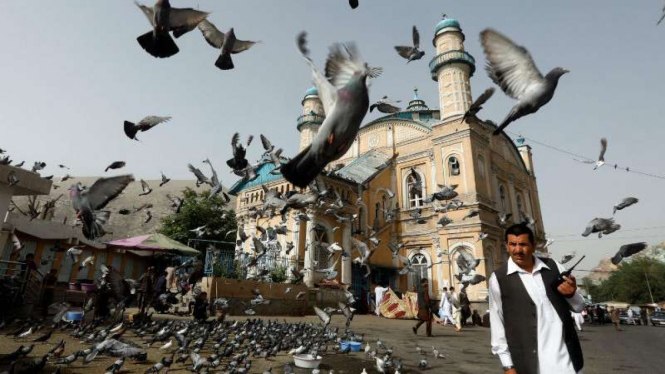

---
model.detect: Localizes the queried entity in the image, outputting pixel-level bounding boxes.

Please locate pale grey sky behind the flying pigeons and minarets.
[0,0,665,275]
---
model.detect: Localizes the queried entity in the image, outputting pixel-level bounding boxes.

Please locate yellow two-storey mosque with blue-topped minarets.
[230,18,545,303]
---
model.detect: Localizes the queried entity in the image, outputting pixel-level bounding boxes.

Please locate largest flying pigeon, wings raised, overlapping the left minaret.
[282,32,382,188]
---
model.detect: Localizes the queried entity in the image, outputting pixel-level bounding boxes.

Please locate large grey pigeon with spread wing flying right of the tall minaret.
[480,29,568,135]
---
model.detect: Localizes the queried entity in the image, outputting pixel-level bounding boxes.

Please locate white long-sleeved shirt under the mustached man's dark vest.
[489,256,584,374]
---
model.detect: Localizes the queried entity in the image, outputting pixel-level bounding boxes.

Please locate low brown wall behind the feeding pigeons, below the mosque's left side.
[201,277,346,316]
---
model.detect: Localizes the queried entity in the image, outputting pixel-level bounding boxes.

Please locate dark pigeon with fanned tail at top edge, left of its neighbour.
[136,0,208,58]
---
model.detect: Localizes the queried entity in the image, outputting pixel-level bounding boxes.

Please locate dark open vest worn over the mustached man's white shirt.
[495,258,584,374]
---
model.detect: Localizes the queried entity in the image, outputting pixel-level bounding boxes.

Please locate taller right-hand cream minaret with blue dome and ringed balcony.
[429,15,476,121]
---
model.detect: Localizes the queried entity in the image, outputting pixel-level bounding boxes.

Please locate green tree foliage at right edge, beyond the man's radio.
[586,258,665,304]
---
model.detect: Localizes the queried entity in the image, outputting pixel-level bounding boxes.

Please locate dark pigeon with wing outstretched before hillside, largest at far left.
[69,174,134,240]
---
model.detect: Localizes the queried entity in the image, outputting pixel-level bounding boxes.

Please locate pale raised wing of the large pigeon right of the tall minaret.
[480,29,544,100]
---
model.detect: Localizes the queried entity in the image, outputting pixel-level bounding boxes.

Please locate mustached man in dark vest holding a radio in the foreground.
[489,224,584,374]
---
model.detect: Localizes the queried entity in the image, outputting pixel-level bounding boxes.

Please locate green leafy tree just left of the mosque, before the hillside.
[159,188,237,249]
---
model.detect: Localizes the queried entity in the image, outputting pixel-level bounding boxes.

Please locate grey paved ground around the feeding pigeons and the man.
[0,315,665,374]
